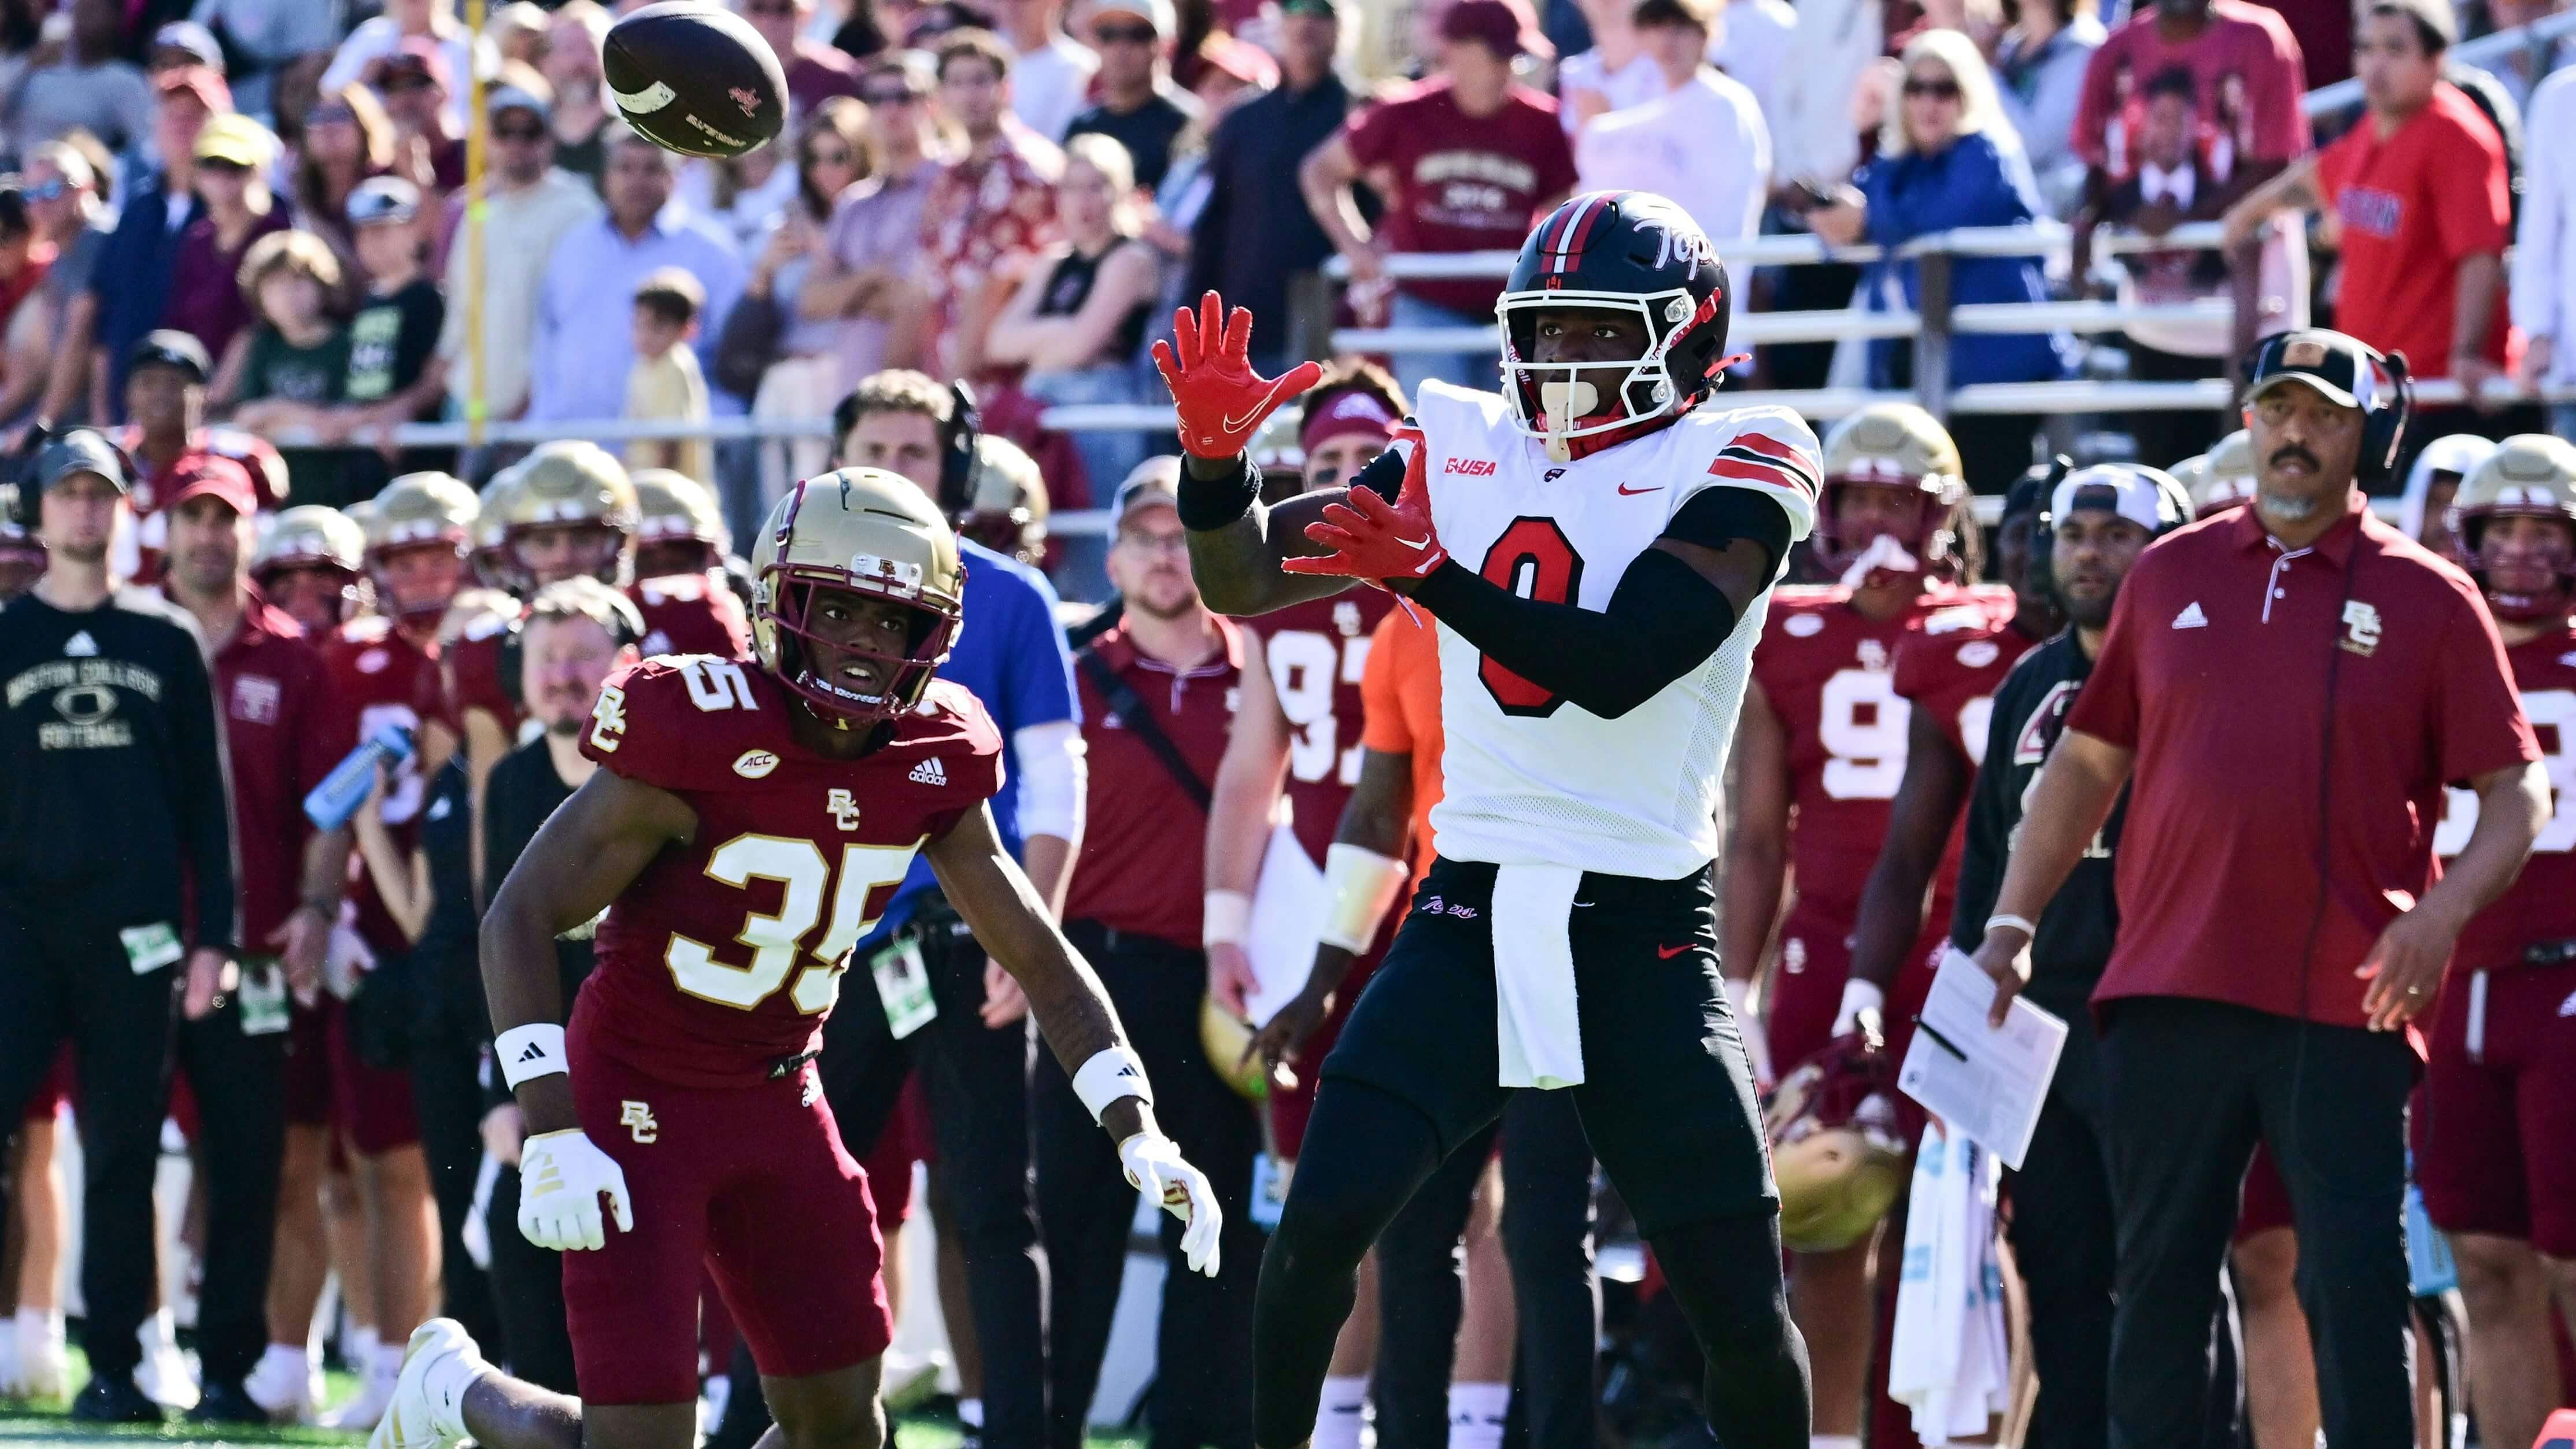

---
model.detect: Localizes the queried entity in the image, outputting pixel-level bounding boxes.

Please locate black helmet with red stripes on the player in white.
[1494,190,1731,458]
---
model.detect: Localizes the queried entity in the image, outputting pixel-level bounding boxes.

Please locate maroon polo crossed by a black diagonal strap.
[1064,618,1244,949]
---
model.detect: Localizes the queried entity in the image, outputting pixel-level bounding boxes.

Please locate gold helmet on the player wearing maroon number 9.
[1813,401,1968,587]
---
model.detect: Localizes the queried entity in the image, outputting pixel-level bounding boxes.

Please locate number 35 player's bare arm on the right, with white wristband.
[927,808,1156,1140]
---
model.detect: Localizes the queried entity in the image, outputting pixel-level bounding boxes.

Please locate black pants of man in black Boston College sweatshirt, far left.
[0,901,180,1380]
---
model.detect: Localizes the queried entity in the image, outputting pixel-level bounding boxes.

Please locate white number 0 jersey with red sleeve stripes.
[1396,381,1824,880]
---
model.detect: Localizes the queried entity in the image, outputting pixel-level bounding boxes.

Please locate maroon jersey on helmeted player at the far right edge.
[2434,628,2576,970]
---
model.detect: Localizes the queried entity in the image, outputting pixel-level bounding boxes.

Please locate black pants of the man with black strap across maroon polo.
[1028,922,1262,1449]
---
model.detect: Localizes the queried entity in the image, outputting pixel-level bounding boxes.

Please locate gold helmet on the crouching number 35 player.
[752,468,966,729]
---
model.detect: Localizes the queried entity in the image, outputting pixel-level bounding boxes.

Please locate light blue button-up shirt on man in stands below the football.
[528,206,742,422]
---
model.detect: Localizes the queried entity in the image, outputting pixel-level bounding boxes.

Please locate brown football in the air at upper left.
[600,0,788,160]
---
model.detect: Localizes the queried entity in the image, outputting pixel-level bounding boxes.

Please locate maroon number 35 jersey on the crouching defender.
[574,654,1002,1086]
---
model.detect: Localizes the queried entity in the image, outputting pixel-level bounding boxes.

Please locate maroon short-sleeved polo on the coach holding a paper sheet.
[2066,507,2540,1027]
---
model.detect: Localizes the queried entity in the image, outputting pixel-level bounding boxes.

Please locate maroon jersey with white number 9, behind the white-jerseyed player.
[1754,584,1986,922]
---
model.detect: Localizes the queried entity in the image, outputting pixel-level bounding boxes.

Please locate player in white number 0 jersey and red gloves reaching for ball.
[1156,190,1821,1449]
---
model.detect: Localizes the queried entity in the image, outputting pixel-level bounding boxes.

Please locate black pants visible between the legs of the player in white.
[1370,1091,1600,1449]
